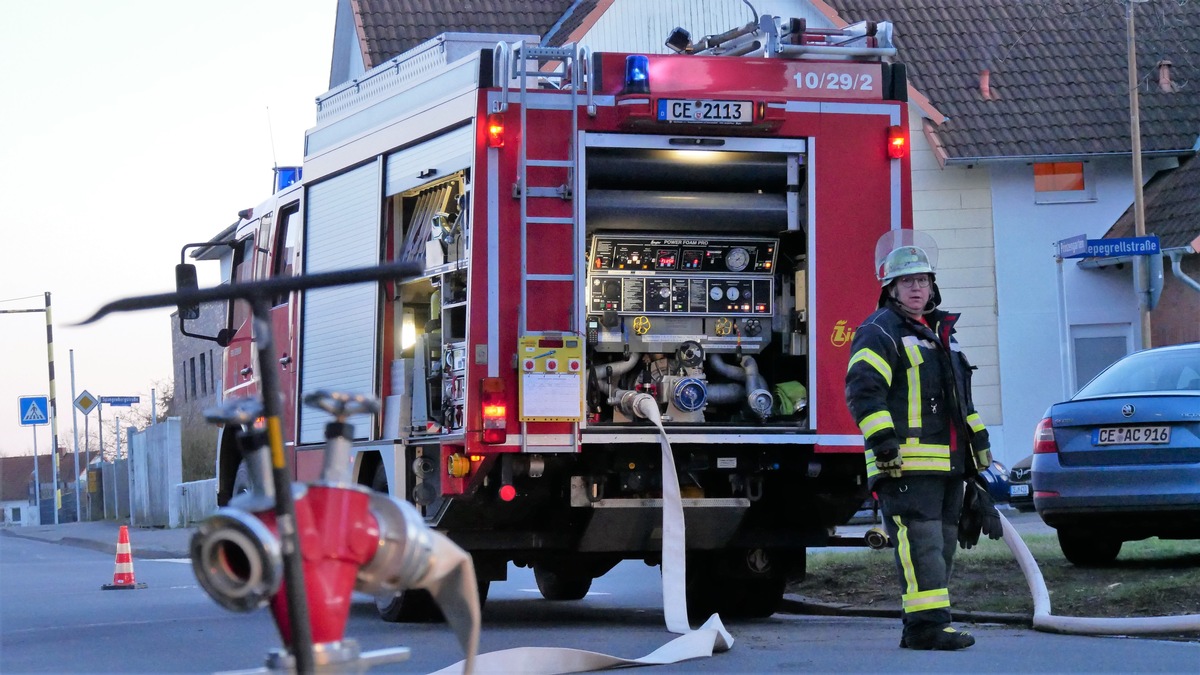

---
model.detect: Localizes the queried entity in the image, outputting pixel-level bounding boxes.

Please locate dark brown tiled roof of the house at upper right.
[826,0,1200,161]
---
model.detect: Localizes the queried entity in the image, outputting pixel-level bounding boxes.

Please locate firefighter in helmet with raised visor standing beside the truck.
[846,231,991,650]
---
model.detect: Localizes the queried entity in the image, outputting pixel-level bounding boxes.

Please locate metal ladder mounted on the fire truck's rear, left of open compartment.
[496,42,590,449]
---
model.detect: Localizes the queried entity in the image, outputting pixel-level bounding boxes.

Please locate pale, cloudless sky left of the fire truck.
[0,0,337,455]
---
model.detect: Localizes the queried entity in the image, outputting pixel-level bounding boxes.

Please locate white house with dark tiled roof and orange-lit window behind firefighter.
[814,0,1200,462]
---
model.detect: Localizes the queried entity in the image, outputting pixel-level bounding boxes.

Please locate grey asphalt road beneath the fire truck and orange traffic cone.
[0,531,1200,675]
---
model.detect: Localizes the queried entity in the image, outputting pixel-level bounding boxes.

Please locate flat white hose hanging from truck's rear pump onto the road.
[433,394,733,675]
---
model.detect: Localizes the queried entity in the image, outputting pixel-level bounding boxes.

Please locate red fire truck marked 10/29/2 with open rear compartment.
[201,17,912,619]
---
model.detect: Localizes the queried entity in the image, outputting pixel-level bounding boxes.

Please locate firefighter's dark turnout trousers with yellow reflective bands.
[875,474,962,634]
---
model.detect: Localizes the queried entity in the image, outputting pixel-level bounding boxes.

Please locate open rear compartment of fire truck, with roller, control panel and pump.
[584,141,810,429]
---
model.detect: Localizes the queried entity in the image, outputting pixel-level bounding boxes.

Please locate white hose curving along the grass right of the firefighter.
[1000,514,1200,635]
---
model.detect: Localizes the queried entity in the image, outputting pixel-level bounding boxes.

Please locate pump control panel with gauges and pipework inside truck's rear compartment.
[587,233,800,424]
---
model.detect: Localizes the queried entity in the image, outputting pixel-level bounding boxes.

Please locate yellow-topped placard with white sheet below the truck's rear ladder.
[517,335,583,422]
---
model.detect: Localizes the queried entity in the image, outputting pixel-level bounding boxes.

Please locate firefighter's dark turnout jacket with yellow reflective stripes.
[846,299,989,489]
